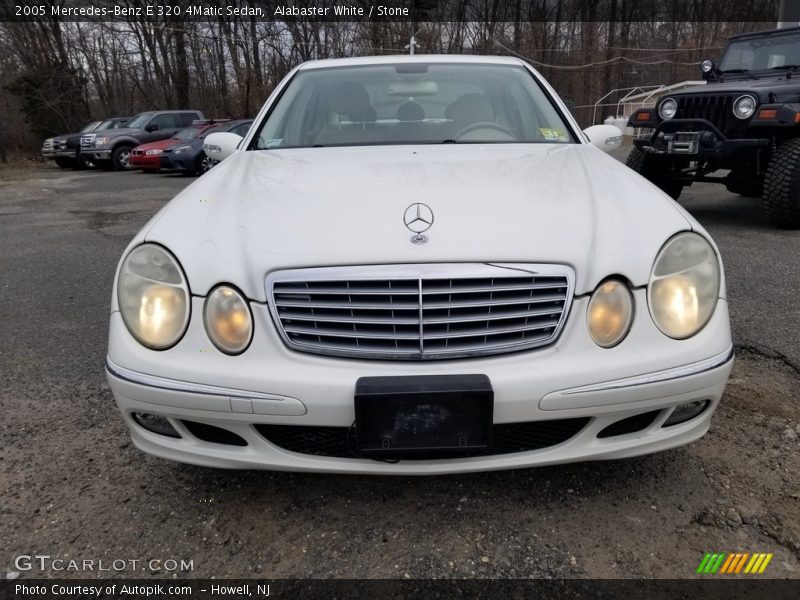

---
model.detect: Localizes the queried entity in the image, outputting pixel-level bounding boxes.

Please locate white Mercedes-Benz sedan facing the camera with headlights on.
[106,55,733,475]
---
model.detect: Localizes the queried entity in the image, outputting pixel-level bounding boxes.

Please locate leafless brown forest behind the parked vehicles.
[0,0,777,158]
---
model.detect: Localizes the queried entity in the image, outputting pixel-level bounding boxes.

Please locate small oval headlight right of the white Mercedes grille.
[586,279,633,348]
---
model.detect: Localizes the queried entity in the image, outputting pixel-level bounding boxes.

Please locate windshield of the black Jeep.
[719,33,800,73]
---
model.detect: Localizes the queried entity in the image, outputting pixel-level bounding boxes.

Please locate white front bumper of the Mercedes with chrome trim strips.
[107,289,733,475]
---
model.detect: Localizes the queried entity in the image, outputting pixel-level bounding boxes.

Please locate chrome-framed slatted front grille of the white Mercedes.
[267,264,573,360]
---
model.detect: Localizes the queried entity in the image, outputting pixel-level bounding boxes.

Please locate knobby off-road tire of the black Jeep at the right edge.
[763,139,800,229]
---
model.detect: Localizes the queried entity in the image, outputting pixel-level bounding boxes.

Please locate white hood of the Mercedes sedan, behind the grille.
[144,144,695,301]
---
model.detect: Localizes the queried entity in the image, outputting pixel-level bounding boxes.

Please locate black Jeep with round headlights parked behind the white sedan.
[627,27,800,229]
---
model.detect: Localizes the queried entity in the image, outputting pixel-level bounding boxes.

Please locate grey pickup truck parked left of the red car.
[80,110,205,171]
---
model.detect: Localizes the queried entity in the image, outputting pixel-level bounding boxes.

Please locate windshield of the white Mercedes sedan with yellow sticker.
[253,63,574,150]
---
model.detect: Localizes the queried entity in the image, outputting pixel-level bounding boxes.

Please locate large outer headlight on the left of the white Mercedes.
[117,244,189,350]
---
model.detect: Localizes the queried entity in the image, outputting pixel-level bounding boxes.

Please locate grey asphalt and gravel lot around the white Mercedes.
[0,158,800,578]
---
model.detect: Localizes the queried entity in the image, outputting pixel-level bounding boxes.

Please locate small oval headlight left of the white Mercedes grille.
[203,285,253,354]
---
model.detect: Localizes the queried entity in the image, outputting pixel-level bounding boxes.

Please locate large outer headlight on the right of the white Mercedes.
[647,232,720,340]
